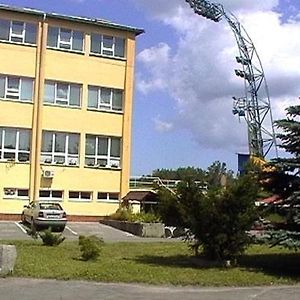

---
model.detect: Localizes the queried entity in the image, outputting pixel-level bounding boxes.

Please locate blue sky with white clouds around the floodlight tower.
[0,0,300,175]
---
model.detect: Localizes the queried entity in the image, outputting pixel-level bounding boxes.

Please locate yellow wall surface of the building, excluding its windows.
[0,12,135,216]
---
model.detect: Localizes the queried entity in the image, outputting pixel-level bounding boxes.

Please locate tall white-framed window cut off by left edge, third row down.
[0,127,30,162]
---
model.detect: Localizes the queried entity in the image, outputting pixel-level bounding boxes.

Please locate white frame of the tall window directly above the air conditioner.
[41,131,80,167]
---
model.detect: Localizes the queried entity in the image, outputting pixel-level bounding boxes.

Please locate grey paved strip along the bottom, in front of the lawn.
[0,278,300,300]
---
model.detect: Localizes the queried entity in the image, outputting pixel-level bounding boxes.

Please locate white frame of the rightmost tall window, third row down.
[85,134,121,169]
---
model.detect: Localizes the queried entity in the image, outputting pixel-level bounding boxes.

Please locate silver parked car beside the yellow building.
[21,201,67,231]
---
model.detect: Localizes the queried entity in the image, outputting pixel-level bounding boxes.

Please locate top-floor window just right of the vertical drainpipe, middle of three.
[47,27,83,52]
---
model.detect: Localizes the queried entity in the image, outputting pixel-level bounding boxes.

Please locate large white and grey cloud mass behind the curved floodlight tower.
[134,0,300,149]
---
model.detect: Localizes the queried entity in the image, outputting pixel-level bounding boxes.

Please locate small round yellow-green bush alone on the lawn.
[78,235,104,261]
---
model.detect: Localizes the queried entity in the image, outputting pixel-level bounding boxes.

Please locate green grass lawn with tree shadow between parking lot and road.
[5,241,300,286]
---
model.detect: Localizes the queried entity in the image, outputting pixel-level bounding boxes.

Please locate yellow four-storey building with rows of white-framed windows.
[0,5,143,219]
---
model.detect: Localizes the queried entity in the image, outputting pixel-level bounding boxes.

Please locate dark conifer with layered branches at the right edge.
[266,105,300,249]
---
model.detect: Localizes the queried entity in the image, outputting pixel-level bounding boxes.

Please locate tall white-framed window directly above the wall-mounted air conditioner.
[41,131,79,166]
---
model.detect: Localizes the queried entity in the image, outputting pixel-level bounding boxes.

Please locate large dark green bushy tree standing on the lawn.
[179,175,258,261]
